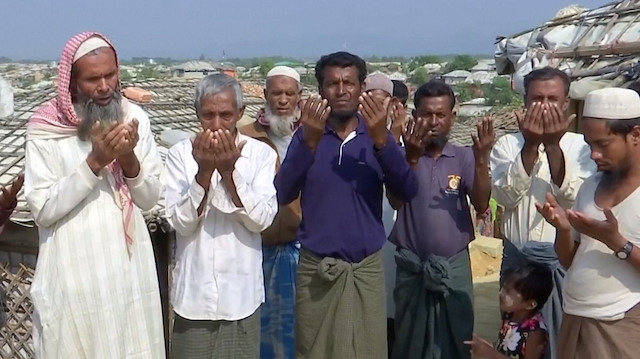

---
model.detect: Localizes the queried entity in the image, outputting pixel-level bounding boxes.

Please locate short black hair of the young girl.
[503,260,553,311]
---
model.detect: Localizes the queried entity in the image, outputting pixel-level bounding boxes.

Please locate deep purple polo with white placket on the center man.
[275,115,418,263]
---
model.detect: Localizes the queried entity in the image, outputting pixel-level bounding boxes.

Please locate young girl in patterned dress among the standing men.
[465,262,553,359]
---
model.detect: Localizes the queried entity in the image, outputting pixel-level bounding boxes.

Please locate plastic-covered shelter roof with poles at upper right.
[495,1,640,99]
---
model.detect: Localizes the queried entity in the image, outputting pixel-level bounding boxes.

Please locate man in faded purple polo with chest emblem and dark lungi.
[389,81,494,359]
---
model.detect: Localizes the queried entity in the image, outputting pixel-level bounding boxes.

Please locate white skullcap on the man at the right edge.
[582,87,640,120]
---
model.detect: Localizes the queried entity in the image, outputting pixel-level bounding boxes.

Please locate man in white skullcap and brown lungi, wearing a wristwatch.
[537,88,640,359]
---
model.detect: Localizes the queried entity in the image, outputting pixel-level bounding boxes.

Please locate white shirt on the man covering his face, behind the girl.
[491,132,596,248]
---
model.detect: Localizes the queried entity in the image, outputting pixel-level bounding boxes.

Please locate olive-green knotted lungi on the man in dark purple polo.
[296,248,388,359]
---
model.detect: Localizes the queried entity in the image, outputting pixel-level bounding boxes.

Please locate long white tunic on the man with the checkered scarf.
[25,105,165,359]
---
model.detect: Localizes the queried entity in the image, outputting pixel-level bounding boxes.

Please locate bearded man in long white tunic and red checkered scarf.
[24,33,166,359]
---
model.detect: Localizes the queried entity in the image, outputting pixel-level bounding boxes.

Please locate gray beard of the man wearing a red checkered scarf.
[73,91,124,141]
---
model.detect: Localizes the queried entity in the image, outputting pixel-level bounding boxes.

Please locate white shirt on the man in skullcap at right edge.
[563,174,640,320]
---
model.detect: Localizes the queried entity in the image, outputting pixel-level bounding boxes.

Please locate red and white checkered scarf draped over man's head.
[27,32,135,255]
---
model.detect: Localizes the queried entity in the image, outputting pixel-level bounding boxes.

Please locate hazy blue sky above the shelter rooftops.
[0,0,609,60]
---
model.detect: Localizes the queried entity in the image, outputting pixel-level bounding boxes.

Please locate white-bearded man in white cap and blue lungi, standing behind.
[240,66,302,359]
